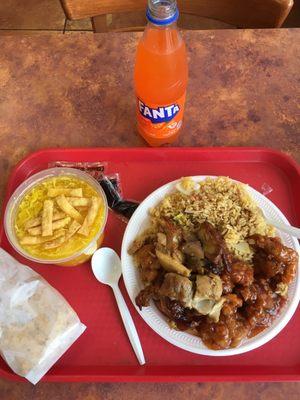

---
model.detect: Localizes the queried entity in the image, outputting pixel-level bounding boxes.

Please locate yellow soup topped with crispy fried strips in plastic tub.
[14,176,105,260]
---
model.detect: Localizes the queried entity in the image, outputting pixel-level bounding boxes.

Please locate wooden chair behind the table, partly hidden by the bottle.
[61,0,294,32]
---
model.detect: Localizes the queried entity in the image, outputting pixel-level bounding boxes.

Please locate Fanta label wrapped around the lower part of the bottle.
[137,94,185,138]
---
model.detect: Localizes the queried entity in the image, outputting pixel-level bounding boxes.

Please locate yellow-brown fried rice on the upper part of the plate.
[150,177,275,261]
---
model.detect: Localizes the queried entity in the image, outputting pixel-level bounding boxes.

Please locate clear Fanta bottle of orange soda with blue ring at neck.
[134,0,188,146]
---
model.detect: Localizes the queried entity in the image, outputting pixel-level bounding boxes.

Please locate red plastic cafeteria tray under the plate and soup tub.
[0,148,300,382]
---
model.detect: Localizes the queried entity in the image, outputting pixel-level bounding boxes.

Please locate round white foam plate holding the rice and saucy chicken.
[121,176,300,356]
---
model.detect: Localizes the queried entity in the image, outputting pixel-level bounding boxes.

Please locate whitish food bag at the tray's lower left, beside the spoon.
[0,248,86,384]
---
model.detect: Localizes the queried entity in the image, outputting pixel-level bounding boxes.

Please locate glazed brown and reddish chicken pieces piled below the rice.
[129,178,298,350]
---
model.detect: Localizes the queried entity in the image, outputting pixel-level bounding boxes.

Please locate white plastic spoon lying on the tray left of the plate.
[92,247,145,365]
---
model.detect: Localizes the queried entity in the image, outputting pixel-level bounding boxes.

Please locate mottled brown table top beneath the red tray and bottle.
[0,29,300,400]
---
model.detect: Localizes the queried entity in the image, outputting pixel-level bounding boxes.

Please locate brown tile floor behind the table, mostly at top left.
[0,0,300,34]
